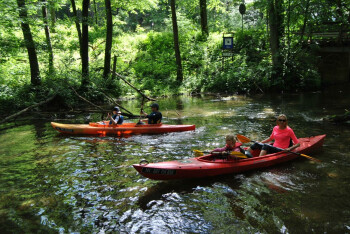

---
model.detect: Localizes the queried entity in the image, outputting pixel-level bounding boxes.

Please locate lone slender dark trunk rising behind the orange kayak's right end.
[170,0,183,82]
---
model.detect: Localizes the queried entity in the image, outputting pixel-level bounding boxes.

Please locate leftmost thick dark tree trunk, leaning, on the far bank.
[17,0,41,85]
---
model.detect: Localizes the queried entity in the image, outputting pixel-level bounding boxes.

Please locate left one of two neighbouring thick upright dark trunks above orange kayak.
[81,0,90,89]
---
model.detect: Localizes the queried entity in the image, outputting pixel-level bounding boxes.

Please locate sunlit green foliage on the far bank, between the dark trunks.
[0,0,349,113]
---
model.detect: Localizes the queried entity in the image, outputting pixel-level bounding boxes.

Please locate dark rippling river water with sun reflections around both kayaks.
[0,89,350,233]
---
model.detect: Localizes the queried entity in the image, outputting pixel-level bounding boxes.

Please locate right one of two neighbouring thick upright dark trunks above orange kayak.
[103,0,113,78]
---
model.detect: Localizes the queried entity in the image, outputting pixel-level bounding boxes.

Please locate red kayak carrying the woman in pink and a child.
[133,135,326,180]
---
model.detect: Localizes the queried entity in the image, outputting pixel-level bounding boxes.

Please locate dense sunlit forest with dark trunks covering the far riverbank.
[0,0,350,114]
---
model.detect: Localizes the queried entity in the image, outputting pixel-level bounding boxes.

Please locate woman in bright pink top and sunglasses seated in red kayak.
[248,114,300,156]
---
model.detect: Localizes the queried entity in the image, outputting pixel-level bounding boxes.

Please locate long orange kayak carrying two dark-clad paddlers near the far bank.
[51,122,196,136]
